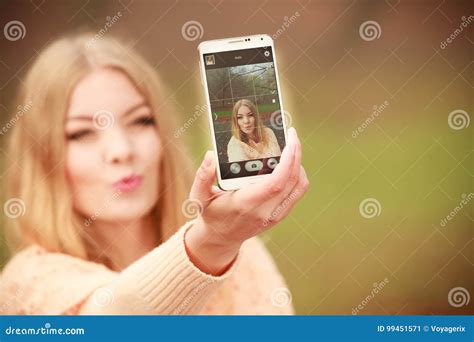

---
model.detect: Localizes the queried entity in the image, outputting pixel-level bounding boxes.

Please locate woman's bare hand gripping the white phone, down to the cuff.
[185,128,309,275]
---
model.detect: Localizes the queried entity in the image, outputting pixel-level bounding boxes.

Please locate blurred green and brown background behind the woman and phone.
[0,0,474,314]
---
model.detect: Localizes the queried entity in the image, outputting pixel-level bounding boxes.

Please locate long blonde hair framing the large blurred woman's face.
[6,34,192,259]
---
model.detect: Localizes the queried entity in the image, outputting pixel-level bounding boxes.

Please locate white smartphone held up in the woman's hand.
[198,34,286,190]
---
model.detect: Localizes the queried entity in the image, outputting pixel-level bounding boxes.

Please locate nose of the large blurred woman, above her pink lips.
[103,128,133,165]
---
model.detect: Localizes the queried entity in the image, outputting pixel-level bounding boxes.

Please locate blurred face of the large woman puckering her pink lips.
[65,68,161,226]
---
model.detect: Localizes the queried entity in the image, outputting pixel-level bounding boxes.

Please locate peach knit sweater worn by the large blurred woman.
[0,221,293,315]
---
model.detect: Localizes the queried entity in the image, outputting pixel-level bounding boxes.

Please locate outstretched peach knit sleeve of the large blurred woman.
[0,221,240,315]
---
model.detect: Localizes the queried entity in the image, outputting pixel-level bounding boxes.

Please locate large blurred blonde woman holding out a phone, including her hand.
[0,35,308,314]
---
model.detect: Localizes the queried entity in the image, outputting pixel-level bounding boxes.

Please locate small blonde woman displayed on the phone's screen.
[227,99,281,163]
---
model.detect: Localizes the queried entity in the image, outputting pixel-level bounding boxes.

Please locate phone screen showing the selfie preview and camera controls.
[204,47,285,179]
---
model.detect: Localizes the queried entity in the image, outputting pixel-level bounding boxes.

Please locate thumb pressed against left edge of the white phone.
[189,151,216,207]
